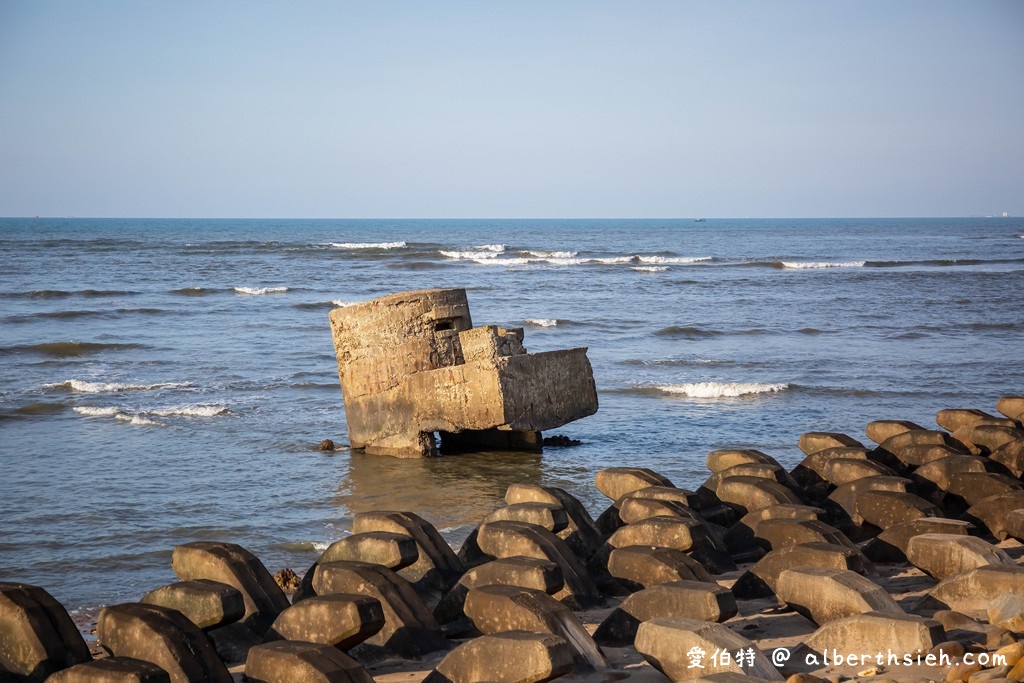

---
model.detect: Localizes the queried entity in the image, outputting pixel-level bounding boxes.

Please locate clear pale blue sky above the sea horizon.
[0,0,1024,217]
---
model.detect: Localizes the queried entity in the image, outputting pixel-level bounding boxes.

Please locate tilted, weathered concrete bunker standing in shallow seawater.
[331,290,597,458]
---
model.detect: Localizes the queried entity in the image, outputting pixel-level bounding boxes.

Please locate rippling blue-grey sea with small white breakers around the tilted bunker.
[0,218,1024,624]
